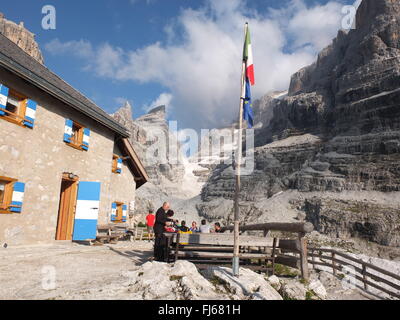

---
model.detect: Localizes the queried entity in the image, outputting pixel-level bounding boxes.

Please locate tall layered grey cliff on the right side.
[199,0,400,251]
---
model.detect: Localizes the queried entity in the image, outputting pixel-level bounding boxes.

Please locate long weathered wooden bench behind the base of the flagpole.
[164,233,277,274]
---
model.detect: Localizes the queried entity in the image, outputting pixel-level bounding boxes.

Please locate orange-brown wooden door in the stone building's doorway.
[56,178,77,240]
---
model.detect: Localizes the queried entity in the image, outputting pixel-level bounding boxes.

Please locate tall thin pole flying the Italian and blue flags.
[232,22,248,277]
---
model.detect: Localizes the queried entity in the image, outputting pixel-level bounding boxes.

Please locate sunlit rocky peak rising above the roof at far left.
[0,12,44,64]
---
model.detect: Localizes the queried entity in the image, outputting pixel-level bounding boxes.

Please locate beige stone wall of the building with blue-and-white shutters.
[0,69,135,245]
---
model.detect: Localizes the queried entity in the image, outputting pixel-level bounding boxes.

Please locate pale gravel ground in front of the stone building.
[0,242,153,300]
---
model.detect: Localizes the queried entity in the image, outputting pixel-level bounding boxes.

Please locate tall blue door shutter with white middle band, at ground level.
[72,181,101,241]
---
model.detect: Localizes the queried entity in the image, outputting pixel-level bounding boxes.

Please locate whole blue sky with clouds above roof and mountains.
[0,0,353,129]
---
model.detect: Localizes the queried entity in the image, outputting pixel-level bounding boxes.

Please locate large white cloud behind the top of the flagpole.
[46,0,342,129]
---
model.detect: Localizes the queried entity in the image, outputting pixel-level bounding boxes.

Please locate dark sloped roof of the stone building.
[0,34,129,138]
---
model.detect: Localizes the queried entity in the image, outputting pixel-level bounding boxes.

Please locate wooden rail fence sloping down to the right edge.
[308,247,400,299]
